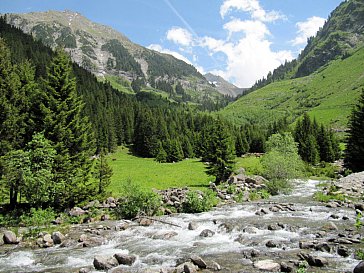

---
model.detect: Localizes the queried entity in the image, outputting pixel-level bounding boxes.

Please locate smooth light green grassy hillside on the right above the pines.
[220,48,364,130]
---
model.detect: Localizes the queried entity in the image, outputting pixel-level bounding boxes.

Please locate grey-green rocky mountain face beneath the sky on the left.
[7,11,226,97]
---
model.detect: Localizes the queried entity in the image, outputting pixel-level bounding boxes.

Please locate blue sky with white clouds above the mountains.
[0,0,341,87]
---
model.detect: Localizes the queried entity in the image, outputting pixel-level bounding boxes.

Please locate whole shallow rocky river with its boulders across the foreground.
[0,177,363,273]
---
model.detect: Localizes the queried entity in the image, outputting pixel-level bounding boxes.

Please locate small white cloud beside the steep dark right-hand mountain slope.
[291,16,325,45]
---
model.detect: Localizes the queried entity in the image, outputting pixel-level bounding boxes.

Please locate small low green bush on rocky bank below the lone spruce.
[182,190,218,213]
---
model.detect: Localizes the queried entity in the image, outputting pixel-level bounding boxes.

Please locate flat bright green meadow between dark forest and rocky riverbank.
[108,147,213,196]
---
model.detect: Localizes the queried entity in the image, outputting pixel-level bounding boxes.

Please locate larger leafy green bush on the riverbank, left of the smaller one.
[114,180,161,219]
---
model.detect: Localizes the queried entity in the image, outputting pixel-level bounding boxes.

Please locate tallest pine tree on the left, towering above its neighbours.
[43,50,95,206]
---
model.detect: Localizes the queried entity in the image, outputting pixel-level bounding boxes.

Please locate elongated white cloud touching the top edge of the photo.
[220,0,286,22]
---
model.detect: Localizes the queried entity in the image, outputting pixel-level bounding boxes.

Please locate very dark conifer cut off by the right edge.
[345,89,364,172]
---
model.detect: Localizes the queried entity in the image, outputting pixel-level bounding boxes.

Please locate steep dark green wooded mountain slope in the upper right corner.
[250,0,364,91]
